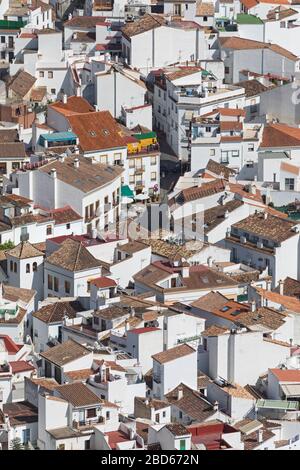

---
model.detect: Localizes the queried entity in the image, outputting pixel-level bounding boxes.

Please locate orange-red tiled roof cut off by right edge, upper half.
[260,124,300,148]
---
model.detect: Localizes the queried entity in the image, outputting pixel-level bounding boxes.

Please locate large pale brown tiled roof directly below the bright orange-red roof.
[39,156,123,193]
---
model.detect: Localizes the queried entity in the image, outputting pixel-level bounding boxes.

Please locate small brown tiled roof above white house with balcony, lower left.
[56,382,102,407]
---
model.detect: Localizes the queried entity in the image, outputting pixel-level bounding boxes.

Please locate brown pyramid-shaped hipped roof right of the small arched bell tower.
[46,238,101,272]
